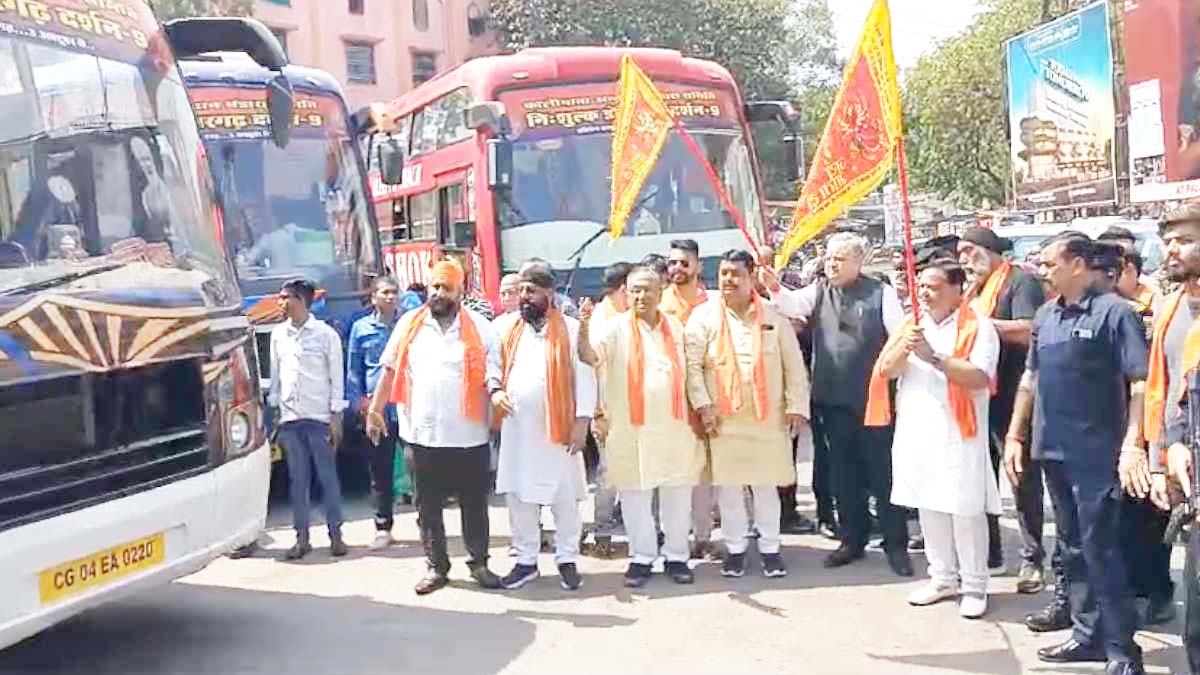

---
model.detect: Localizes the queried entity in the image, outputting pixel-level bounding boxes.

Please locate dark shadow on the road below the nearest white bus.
[0,584,535,675]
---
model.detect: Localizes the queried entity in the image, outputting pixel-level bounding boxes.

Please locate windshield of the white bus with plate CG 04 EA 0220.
[0,35,232,294]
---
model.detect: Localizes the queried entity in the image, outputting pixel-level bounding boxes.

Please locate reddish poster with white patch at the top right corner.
[1124,0,1200,202]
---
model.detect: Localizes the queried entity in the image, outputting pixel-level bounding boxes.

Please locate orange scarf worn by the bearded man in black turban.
[497,307,575,446]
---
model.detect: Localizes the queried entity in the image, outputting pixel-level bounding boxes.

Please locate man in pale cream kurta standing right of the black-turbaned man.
[596,268,704,587]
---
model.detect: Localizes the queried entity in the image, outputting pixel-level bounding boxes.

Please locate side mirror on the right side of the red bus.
[745,101,804,199]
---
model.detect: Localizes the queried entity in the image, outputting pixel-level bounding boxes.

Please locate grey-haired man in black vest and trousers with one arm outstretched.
[761,232,912,577]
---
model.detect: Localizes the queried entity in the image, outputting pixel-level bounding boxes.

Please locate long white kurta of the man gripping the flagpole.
[892,312,1000,515]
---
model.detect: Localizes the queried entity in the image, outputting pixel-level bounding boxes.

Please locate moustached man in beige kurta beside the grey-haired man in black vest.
[686,251,809,577]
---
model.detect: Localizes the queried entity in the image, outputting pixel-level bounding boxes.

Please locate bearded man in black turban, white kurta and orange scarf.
[493,265,596,590]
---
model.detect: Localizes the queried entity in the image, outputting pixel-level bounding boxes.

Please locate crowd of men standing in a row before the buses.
[271,205,1200,674]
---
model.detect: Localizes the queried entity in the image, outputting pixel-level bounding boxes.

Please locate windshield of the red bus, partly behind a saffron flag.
[497,83,762,267]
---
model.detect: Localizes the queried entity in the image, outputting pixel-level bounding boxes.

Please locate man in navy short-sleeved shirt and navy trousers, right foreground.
[1004,234,1150,675]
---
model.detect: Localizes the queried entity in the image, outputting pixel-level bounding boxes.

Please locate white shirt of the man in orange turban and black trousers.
[383,307,500,448]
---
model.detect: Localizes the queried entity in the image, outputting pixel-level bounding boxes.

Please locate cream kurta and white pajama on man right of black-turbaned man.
[596,312,704,565]
